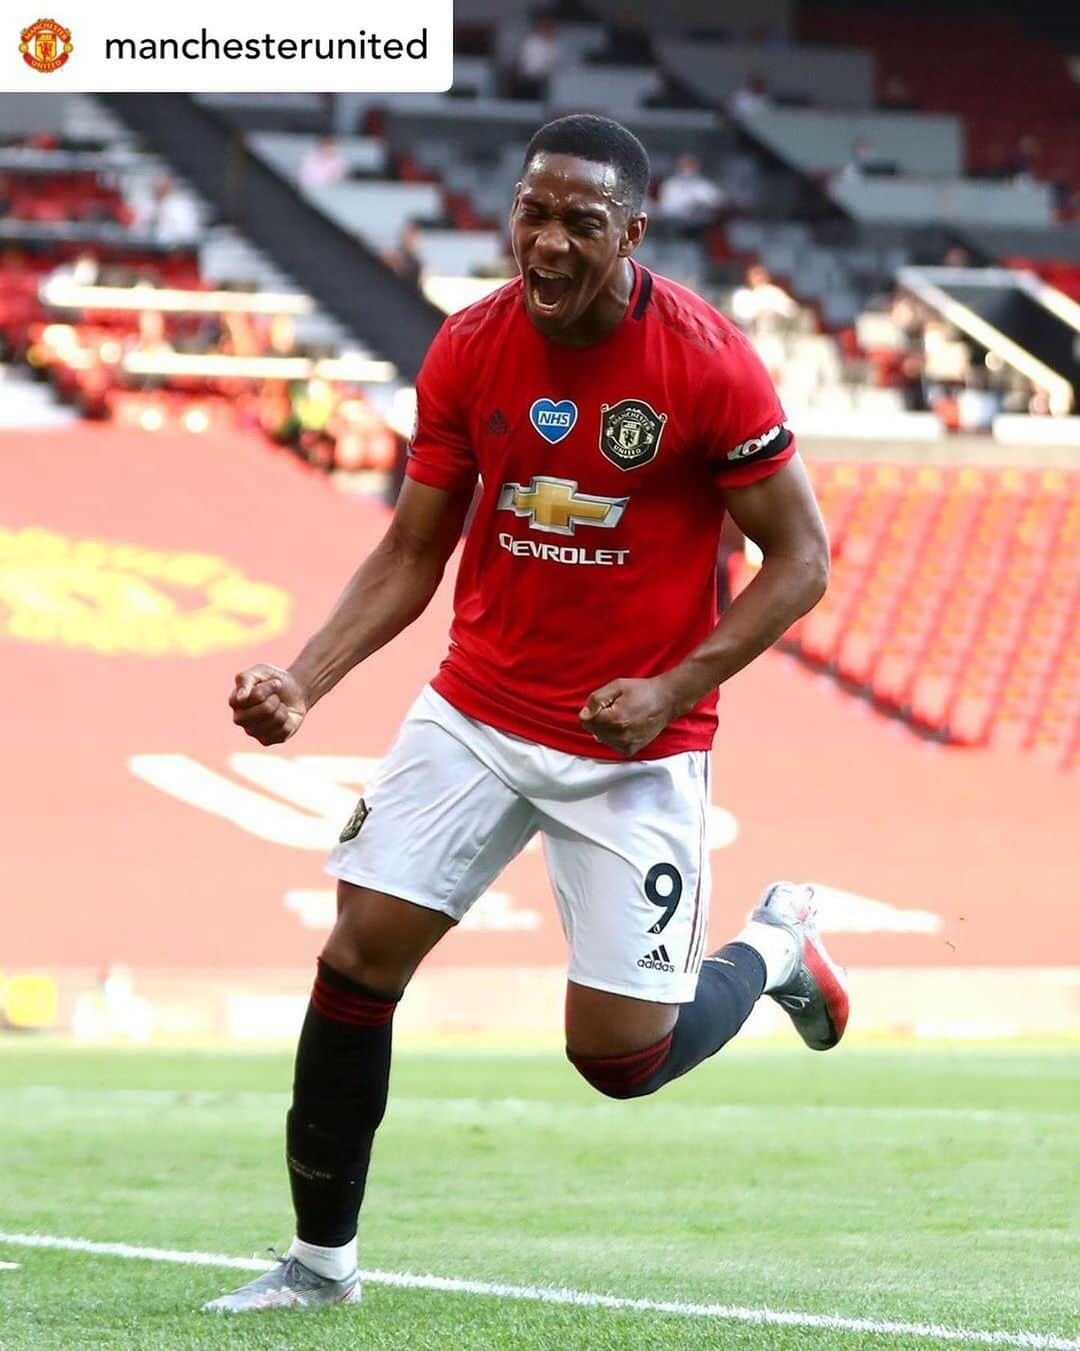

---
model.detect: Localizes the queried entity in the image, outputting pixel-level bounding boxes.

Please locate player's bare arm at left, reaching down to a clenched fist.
[228,478,472,746]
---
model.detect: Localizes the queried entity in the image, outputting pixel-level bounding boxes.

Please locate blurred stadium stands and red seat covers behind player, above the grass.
[0,0,1080,1043]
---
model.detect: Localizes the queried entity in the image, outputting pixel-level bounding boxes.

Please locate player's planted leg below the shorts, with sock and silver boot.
[204,882,453,1312]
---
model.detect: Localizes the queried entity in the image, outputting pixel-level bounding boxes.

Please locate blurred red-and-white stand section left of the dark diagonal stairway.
[0,100,400,490]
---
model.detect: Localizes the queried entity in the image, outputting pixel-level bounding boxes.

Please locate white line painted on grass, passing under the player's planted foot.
[0,1231,1080,1351]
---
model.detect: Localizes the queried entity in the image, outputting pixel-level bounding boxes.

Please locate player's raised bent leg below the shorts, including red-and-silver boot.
[566,882,848,1098]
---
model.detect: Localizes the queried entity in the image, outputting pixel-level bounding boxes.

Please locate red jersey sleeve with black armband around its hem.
[699,331,795,488]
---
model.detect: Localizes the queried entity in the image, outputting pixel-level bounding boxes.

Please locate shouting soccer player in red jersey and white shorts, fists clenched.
[205,116,848,1310]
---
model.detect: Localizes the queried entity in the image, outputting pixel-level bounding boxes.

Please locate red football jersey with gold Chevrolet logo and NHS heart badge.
[407,263,795,759]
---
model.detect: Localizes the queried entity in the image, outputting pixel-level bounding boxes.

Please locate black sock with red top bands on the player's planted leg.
[285,958,400,1247]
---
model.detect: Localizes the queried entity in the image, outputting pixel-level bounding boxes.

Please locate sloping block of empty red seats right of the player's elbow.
[785,465,1080,767]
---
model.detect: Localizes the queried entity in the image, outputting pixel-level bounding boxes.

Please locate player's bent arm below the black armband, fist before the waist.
[580,455,829,755]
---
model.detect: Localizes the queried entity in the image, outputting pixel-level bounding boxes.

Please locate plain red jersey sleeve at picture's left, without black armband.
[406,323,477,492]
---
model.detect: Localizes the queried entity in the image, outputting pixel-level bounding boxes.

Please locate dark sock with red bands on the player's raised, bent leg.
[566,943,765,1098]
